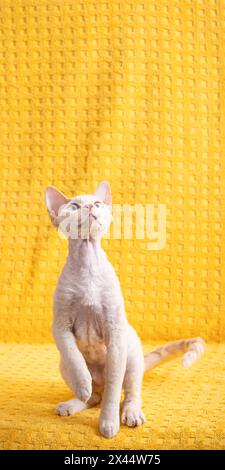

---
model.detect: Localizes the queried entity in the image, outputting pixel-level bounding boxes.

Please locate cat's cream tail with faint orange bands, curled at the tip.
[145,338,206,372]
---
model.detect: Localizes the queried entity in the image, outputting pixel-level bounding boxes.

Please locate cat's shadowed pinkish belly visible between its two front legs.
[73,308,106,365]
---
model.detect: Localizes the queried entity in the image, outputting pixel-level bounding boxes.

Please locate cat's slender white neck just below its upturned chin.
[67,238,105,269]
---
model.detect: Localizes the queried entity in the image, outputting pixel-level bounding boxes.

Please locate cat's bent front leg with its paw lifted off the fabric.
[52,322,92,402]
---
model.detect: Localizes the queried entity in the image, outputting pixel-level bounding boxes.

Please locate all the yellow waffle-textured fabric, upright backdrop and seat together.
[0,0,225,449]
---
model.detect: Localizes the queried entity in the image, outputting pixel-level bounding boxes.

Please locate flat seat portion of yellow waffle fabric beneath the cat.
[0,344,225,449]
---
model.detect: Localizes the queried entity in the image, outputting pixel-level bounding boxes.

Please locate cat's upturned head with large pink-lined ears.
[45,181,112,239]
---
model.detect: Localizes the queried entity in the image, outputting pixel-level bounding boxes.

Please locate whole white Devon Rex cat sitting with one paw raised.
[46,181,205,437]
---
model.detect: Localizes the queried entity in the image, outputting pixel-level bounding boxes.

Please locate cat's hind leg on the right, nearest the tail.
[121,339,145,427]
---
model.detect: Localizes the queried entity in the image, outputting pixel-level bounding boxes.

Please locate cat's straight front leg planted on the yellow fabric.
[99,319,127,437]
